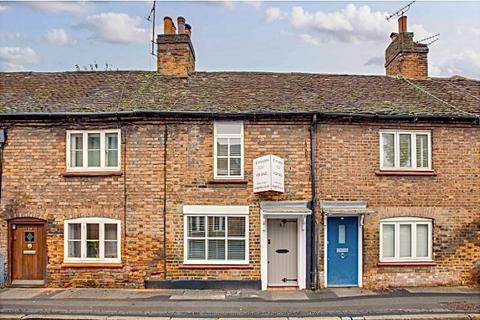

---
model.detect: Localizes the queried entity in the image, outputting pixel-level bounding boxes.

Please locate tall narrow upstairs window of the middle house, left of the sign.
[213,121,243,179]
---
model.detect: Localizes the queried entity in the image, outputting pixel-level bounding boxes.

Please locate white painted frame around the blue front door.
[323,213,364,288]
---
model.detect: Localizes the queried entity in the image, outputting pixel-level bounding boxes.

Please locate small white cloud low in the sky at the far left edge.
[0,47,40,71]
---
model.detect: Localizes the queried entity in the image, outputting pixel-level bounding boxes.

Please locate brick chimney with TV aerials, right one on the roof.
[385,16,428,80]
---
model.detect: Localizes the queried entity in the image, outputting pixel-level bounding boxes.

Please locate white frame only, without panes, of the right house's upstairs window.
[379,130,432,171]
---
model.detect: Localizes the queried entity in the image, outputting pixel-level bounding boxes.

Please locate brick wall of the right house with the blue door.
[317,123,480,288]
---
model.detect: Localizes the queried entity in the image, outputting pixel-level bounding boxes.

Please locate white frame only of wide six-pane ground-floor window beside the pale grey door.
[183,205,250,265]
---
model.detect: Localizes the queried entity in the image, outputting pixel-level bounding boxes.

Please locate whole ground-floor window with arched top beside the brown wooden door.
[64,218,121,263]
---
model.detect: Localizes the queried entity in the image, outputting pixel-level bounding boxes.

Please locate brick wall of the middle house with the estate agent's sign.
[161,121,311,280]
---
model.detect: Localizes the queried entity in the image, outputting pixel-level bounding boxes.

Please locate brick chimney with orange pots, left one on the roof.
[157,17,195,77]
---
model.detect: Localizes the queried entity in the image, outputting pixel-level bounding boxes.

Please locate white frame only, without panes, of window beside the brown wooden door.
[63,218,122,263]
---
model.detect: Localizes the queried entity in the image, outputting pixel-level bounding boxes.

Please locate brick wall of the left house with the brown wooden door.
[0,124,168,287]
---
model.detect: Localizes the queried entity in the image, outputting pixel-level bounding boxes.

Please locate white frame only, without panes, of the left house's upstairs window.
[66,129,122,172]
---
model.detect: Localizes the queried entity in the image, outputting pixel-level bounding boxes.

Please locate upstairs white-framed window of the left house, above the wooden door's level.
[67,130,120,171]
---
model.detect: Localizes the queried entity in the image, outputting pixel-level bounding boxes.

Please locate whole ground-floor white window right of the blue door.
[380,218,432,262]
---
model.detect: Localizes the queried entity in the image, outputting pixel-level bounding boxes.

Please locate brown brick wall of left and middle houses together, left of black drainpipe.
[0,121,310,287]
